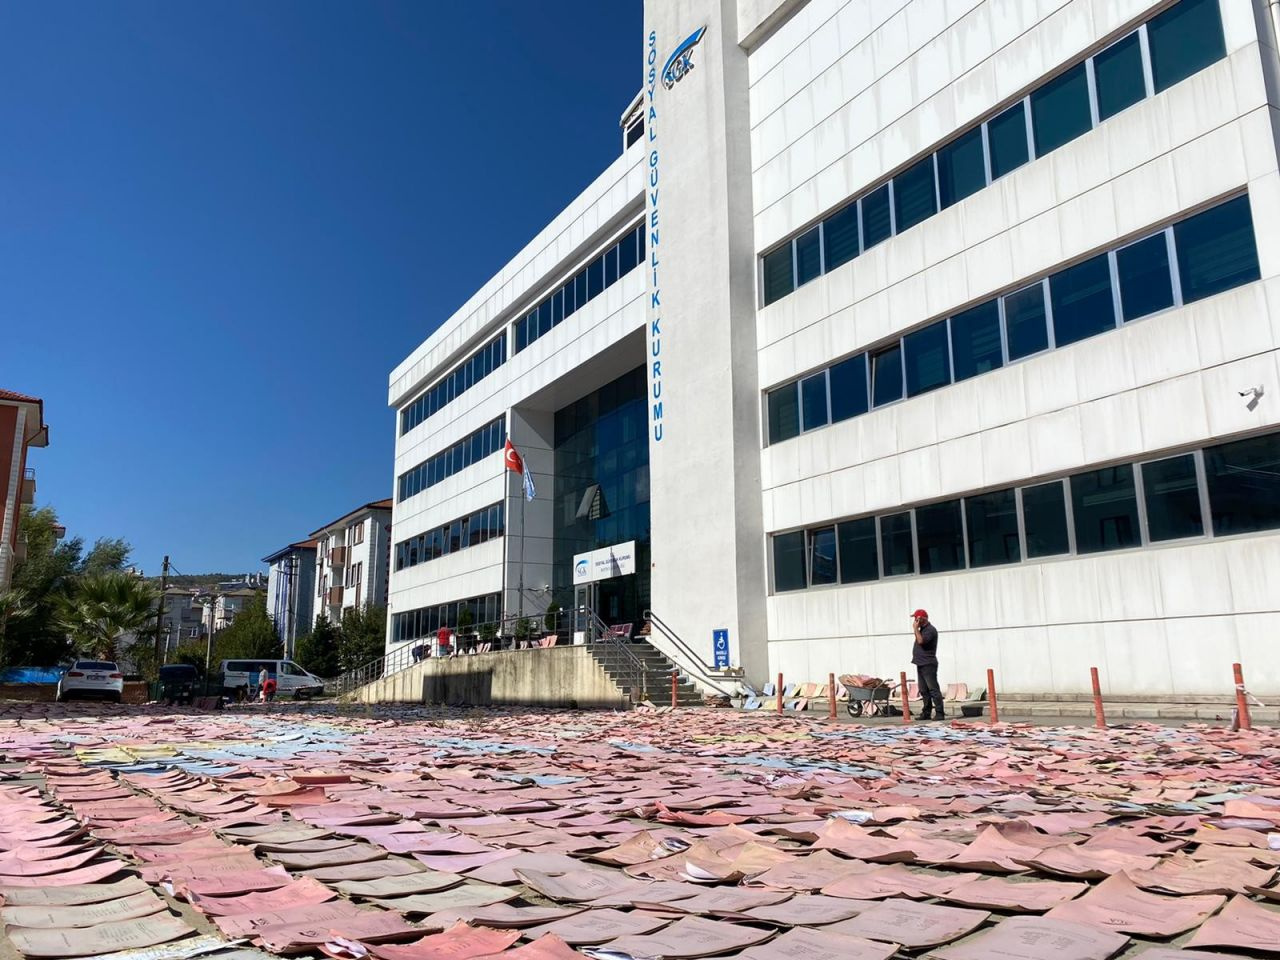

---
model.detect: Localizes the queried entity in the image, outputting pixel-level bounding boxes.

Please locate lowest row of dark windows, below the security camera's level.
[772,433,1280,591]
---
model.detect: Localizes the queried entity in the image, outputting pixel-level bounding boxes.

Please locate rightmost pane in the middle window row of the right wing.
[1174,199,1260,303]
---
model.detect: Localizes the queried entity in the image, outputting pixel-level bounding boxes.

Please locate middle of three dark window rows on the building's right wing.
[768,195,1261,443]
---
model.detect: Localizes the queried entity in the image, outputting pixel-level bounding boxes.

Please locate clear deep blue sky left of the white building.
[0,0,643,572]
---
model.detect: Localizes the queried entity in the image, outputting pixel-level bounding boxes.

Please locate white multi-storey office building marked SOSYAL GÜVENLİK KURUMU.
[388,0,1280,695]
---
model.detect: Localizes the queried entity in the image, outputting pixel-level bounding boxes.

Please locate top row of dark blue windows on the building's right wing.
[762,0,1226,305]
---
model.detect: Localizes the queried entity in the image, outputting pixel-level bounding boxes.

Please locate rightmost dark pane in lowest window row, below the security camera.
[1204,434,1280,536]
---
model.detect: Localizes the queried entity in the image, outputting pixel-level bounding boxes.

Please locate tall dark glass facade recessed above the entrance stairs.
[552,366,650,623]
